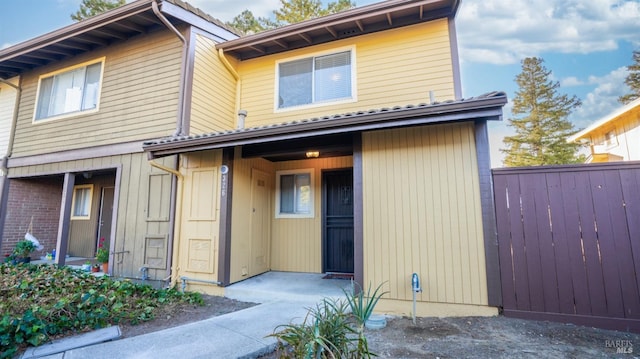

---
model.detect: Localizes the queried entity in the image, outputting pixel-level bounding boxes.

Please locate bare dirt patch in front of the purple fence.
[260,317,640,359]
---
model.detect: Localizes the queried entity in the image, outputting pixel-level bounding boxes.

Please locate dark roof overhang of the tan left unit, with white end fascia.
[0,0,237,79]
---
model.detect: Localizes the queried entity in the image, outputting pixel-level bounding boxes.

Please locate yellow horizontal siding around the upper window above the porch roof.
[238,19,455,127]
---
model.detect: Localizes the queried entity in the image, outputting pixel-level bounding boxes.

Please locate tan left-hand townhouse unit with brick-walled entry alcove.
[0,0,238,284]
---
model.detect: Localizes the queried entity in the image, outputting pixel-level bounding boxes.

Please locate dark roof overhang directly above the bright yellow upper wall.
[216,0,460,60]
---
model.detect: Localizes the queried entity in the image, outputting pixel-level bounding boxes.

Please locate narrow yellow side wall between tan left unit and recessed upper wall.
[194,35,236,134]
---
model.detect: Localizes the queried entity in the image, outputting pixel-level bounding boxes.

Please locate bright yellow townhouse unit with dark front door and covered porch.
[144,0,507,315]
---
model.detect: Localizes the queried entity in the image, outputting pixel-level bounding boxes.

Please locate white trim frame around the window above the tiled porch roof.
[273,46,358,113]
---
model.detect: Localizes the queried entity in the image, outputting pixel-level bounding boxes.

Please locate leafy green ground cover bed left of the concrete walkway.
[0,263,203,359]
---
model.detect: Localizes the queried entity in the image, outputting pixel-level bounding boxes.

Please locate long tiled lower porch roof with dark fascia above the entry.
[143,92,507,158]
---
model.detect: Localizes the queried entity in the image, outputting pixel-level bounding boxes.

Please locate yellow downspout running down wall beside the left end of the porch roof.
[149,159,184,286]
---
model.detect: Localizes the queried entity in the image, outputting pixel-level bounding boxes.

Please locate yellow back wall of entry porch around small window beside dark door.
[271,156,353,273]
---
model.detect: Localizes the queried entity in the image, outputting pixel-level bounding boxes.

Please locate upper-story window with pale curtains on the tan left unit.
[34,58,104,121]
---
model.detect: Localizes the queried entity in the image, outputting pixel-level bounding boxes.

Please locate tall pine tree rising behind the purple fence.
[501,57,583,167]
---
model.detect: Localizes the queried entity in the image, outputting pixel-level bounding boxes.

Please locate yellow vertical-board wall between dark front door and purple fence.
[363,123,487,313]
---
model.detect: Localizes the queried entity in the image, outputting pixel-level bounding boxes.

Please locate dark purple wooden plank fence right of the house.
[493,162,640,332]
